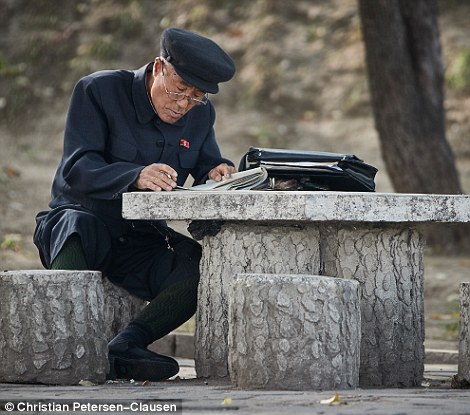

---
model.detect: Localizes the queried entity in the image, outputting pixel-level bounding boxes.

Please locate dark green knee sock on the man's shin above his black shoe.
[136,277,199,341]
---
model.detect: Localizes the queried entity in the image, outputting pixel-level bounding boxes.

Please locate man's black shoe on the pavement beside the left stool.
[107,341,180,381]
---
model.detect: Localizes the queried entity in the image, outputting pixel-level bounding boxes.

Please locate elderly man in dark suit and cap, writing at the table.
[34,28,235,381]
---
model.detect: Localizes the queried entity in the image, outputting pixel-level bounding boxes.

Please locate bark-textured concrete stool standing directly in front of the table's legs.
[228,274,361,390]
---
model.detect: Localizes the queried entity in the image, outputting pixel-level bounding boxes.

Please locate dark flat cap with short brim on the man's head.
[160,27,235,94]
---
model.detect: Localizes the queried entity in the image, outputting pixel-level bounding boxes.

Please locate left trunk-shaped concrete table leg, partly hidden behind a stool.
[195,222,320,377]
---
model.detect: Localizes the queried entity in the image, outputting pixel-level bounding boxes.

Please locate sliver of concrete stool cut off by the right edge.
[457,282,470,383]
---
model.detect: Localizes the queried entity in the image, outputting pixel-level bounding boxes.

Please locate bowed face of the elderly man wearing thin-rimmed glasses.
[149,58,207,124]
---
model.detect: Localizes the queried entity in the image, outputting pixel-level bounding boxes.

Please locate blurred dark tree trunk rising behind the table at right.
[359,0,461,194]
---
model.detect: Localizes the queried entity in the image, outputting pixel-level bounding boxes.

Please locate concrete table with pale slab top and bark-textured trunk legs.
[123,191,470,387]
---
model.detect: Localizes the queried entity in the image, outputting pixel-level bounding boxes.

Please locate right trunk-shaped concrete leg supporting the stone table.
[321,224,424,387]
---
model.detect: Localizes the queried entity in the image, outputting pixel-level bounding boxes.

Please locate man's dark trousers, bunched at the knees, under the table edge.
[34,206,201,301]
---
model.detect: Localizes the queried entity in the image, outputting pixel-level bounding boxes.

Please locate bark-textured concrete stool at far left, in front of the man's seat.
[0,270,108,385]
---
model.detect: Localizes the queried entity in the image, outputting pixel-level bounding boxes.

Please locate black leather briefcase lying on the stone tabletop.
[239,147,377,192]
